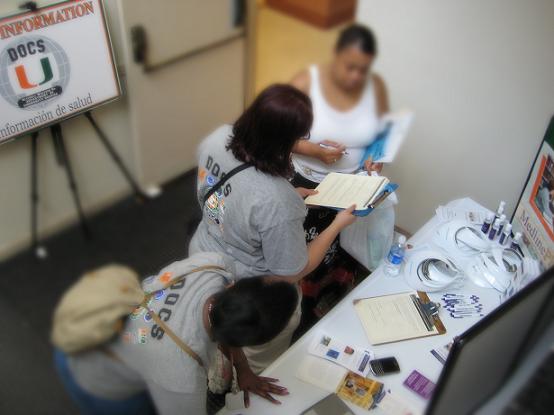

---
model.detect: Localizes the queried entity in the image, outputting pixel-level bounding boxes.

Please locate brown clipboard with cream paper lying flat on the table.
[353,291,446,345]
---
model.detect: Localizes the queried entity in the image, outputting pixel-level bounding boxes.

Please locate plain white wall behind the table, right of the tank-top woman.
[357,0,554,232]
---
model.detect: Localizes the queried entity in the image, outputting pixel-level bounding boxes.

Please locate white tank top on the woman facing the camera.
[292,65,379,182]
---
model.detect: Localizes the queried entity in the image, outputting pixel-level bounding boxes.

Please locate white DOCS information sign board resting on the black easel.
[0,0,121,144]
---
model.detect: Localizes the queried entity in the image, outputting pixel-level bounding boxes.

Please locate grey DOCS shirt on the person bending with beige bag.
[68,253,234,415]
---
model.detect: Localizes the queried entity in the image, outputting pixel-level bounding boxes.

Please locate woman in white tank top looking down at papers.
[291,25,389,311]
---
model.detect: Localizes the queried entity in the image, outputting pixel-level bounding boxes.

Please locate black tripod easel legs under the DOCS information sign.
[20,1,153,259]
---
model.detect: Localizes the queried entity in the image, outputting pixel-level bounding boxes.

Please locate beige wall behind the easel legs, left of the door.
[0,0,134,258]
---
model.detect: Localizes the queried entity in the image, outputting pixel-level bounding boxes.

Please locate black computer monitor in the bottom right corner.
[426,268,554,415]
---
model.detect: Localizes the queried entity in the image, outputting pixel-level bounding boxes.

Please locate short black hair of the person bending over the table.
[210,277,298,347]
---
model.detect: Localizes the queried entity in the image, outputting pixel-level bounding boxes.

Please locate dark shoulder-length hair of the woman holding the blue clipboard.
[227,84,313,178]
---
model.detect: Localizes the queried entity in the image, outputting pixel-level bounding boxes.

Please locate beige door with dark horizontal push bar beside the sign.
[118,0,246,183]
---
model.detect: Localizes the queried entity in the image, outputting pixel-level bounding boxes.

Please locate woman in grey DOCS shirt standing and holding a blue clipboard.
[189,85,355,373]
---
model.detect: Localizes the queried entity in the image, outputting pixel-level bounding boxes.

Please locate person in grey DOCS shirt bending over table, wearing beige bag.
[55,253,298,415]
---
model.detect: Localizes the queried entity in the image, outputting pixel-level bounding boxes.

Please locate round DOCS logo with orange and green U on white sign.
[0,36,70,110]
